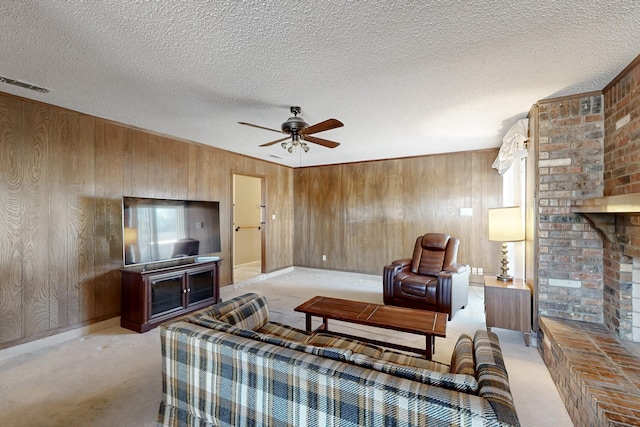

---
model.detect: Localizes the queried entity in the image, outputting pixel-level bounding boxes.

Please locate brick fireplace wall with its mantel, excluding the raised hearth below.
[537,53,640,342]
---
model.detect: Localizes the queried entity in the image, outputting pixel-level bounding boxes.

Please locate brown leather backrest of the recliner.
[411,233,460,276]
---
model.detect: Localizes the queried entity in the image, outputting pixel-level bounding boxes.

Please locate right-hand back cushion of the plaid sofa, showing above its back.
[351,353,478,394]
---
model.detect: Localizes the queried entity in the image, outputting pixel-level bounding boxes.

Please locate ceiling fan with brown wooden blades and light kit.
[238,107,344,153]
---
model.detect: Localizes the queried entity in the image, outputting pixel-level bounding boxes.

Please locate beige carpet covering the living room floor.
[0,268,573,427]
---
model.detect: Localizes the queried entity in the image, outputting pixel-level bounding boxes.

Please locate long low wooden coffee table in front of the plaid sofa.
[294,296,449,360]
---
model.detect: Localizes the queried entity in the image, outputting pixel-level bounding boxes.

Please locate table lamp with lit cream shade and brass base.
[489,206,524,282]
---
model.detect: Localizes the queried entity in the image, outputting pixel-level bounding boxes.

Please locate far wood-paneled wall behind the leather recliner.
[294,149,502,281]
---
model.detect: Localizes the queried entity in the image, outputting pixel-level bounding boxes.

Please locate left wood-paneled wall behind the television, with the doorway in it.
[0,93,293,348]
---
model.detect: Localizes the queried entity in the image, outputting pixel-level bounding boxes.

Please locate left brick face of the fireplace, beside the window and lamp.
[538,93,604,323]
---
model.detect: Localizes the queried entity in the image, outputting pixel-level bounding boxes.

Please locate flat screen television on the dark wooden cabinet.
[122,196,221,266]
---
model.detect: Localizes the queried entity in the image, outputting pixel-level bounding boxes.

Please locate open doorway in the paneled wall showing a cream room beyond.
[232,173,265,283]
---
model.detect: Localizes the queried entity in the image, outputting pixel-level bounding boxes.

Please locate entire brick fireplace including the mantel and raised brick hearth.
[532,56,640,426]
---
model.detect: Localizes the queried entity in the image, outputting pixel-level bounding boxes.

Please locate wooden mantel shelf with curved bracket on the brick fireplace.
[571,193,640,243]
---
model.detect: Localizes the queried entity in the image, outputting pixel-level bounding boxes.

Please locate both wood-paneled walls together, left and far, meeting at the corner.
[0,88,502,348]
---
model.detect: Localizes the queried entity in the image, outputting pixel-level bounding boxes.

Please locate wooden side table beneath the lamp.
[484,275,531,346]
